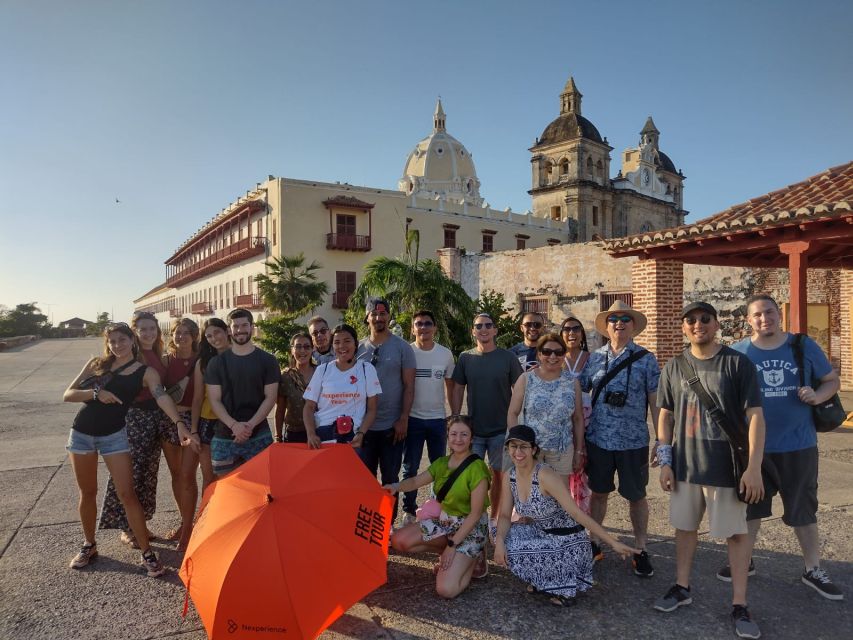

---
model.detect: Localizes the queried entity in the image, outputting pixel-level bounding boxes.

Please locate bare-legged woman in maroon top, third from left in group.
[160,318,201,547]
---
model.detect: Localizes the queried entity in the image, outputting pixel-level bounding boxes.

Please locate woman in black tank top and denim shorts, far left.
[63,323,189,577]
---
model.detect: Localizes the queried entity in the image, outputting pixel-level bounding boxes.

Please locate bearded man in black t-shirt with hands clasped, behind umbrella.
[204,309,281,476]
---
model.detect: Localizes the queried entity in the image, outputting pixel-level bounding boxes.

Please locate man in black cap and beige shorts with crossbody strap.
[654,302,764,638]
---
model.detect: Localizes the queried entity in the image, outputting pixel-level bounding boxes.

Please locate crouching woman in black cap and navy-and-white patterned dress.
[495,425,638,606]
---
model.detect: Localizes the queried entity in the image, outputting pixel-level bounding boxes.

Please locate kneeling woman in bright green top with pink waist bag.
[385,416,492,598]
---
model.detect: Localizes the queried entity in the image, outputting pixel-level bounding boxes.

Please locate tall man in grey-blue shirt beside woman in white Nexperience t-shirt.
[356,298,417,521]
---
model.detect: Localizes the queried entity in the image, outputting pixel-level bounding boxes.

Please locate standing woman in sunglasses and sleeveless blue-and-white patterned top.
[506,333,584,480]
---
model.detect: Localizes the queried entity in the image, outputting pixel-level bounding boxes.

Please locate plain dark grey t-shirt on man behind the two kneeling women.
[453,349,522,438]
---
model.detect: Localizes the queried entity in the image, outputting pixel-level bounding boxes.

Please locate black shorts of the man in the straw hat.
[586,440,649,502]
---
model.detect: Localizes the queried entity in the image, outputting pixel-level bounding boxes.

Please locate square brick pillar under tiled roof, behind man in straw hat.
[631,260,684,367]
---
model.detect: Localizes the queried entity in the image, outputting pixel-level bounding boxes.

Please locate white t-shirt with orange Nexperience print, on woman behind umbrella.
[302,362,382,429]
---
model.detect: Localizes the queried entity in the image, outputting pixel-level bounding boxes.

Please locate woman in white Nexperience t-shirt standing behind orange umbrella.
[302,324,382,449]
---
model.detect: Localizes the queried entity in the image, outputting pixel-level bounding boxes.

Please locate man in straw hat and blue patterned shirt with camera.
[580,300,660,578]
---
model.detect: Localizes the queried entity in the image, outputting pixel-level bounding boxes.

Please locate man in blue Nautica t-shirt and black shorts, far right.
[717,294,844,600]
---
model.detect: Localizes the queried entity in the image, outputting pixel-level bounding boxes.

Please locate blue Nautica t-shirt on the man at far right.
[733,335,832,453]
